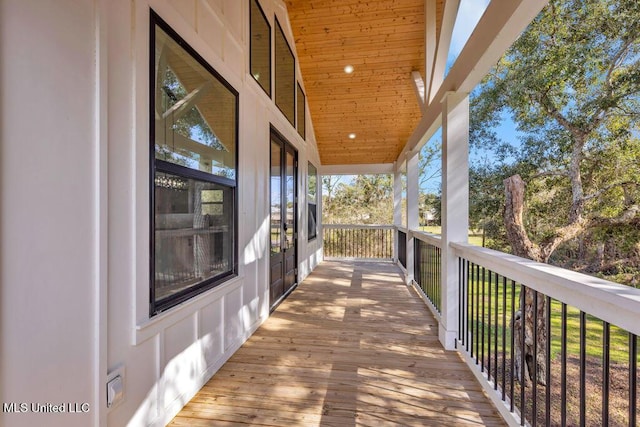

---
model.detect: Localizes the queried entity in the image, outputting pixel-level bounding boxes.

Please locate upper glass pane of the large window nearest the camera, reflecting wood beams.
[153,26,237,179]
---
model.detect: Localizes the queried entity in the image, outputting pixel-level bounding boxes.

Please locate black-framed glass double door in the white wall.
[269,129,298,309]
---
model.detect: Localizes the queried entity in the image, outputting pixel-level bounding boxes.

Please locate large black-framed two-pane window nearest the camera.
[150,12,238,316]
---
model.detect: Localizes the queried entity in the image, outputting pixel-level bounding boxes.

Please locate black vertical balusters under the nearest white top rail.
[457,258,640,426]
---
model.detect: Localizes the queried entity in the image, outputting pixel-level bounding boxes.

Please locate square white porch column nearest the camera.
[439,92,469,350]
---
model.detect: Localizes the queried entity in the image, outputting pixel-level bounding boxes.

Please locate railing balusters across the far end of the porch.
[323,224,394,260]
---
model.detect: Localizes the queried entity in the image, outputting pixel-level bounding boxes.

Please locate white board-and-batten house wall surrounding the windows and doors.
[0,0,321,426]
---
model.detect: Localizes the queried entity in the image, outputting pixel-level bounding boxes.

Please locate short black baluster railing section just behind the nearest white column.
[413,237,442,313]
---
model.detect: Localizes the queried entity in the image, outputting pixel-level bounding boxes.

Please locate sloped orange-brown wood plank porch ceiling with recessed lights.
[286,0,443,165]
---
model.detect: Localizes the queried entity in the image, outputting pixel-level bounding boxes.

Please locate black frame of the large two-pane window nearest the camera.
[149,10,240,317]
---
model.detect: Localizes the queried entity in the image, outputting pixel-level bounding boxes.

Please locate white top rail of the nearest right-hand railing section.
[451,243,640,335]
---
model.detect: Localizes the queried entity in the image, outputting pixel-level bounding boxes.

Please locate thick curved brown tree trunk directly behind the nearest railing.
[504,175,547,385]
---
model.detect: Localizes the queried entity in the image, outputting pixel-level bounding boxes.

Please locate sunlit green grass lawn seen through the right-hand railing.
[421,236,640,425]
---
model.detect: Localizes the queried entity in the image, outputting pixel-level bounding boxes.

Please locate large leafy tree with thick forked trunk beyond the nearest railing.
[472,0,640,382]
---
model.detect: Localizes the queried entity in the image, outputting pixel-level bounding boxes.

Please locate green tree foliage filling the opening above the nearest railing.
[470,0,640,283]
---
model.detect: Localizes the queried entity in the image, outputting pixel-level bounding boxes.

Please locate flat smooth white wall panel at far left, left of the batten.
[0,0,97,426]
